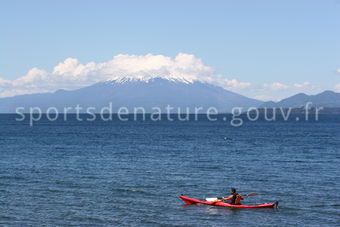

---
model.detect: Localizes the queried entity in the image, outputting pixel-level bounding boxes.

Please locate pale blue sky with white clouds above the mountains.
[0,0,340,100]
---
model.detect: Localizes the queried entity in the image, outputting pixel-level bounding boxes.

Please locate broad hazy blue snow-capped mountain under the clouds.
[0,78,263,113]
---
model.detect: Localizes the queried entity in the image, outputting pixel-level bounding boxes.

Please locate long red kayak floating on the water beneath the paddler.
[179,195,279,208]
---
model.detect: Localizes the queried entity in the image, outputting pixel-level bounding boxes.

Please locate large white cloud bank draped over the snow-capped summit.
[0,53,251,97]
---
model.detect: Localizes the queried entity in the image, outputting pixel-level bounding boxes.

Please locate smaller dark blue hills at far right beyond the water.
[261,91,340,108]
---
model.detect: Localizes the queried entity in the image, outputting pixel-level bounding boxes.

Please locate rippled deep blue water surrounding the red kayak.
[0,115,340,226]
